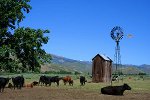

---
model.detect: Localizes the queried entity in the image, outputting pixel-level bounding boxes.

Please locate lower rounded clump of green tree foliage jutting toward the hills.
[11,27,51,71]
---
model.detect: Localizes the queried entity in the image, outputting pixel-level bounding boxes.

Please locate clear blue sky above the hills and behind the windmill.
[20,0,150,65]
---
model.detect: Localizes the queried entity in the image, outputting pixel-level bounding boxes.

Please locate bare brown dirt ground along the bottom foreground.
[0,86,150,100]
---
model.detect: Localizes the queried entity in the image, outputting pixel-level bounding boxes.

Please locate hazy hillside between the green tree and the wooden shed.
[42,54,92,73]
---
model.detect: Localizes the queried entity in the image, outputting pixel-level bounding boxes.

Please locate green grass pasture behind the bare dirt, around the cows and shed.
[0,73,150,92]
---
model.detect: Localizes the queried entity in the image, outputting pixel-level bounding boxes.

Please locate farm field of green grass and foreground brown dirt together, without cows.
[0,75,150,100]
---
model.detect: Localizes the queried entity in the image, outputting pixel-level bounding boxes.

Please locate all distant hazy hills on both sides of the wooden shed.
[41,54,150,74]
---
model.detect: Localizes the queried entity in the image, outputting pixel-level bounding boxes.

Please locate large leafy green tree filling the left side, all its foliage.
[0,0,51,72]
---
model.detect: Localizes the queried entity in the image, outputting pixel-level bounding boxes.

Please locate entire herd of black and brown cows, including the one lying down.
[0,75,131,95]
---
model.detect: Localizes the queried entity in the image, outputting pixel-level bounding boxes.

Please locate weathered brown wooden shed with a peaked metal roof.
[92,54,112,82]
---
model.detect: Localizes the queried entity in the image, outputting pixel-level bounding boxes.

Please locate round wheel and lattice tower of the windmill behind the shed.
[110,26,124,74]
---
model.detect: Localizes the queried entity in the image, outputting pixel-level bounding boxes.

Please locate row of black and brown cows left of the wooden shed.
[0,75,87,92]
